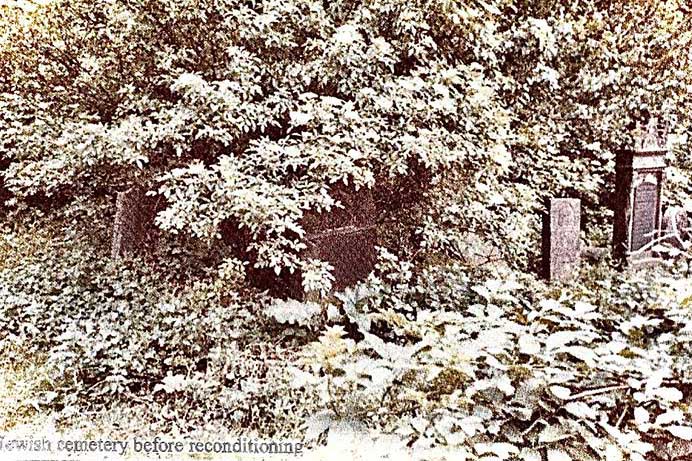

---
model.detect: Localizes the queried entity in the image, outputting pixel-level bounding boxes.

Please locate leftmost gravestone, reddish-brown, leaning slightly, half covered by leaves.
[111,187,159,259]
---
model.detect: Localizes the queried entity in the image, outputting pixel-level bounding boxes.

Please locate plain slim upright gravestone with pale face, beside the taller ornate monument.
[543,198,581,281]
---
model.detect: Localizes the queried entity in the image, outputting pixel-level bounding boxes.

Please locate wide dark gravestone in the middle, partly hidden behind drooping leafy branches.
[228,187,377,300]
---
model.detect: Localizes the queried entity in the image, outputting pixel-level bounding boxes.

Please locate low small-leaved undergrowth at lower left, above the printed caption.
[0,205,318,435]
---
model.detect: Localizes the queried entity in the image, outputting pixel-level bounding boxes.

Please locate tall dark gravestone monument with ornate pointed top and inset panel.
[613,119,667,263]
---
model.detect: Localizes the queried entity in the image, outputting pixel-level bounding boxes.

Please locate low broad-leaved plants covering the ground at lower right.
[296,256,692,460]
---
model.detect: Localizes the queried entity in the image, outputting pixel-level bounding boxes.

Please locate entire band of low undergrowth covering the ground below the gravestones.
[0,210,692,460]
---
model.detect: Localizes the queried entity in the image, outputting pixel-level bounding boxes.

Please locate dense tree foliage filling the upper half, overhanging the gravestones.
[0,0,692,280]
